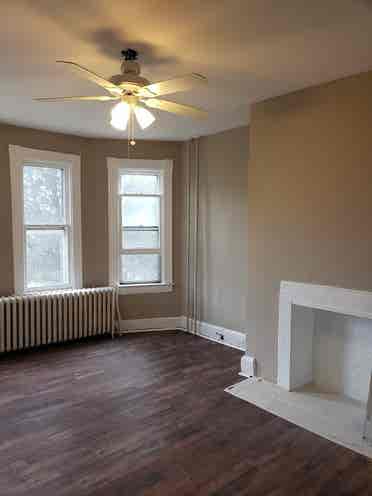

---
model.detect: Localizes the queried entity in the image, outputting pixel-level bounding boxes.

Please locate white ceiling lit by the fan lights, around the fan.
[0,0,372,139]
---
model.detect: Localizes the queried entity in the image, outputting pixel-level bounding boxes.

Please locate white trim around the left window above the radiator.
[9,145,82,295]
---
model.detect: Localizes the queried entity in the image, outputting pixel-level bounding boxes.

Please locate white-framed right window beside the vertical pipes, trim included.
[108,158,172,293]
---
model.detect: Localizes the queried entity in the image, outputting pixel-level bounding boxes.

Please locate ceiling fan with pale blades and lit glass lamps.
[35,48,207,145]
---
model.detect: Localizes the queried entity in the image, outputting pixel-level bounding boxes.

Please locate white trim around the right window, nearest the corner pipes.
[107,157,173,294]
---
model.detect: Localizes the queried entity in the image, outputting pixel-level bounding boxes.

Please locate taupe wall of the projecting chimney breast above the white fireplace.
[247,72,372,379]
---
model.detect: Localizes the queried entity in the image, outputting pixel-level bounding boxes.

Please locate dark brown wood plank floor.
[0,332,372,496]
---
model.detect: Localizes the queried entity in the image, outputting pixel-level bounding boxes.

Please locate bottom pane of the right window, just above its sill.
[120,253,161,283]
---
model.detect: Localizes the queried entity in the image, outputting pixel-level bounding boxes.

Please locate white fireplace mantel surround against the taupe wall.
[278,281,372,391]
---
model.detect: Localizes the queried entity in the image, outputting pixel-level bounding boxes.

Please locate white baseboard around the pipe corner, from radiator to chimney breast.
[120,316,250,351]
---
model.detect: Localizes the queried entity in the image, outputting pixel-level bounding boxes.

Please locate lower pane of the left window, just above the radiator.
[26,229,68,288]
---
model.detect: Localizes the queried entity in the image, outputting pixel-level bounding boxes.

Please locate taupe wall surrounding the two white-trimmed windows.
[0,125,184,318]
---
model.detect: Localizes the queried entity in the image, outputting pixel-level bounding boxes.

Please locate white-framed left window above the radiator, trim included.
[9,146,81,294]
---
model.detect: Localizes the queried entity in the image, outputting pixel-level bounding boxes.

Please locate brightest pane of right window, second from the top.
[121,196,160,227]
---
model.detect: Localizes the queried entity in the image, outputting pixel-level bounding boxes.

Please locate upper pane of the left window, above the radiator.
[23,165,65,224]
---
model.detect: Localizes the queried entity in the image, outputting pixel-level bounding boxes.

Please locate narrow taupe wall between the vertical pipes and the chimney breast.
[199,127,249,331]
